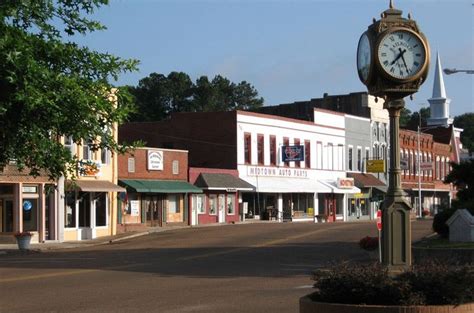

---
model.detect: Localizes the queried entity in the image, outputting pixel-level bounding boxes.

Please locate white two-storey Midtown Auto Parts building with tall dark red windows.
[237,110,360,221]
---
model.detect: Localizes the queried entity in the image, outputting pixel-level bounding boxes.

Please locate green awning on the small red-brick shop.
[119,179,202,193]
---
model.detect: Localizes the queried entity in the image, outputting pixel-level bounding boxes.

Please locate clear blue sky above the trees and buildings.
[77,0,474,116]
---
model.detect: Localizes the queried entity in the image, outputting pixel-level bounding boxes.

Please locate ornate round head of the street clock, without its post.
[357,1,430,99]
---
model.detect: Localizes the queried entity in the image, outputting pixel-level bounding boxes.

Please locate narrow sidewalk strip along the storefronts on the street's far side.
[0,220,270,257]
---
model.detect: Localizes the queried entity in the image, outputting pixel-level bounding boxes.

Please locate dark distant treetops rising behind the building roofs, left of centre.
[130,72,263,121]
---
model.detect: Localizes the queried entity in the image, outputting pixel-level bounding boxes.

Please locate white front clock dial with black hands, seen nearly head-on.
[377,30,426,80]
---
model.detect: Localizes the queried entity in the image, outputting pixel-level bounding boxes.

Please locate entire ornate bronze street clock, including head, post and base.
[357,0,430,273]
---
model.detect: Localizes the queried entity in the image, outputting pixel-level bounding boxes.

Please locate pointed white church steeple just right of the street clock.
[427,53,453,127]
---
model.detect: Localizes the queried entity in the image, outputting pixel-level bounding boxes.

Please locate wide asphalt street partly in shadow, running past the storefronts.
[0,221,431,313]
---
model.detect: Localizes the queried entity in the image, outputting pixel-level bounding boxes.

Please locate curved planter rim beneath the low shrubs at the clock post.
[300,296,474,313]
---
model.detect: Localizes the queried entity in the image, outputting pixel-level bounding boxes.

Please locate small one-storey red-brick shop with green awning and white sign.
[117,147,202,232]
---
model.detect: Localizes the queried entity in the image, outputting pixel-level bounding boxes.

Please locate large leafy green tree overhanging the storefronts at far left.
[0,0,137,179]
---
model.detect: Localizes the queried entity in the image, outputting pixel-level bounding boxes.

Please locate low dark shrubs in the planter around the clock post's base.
[310,263,474,305]
